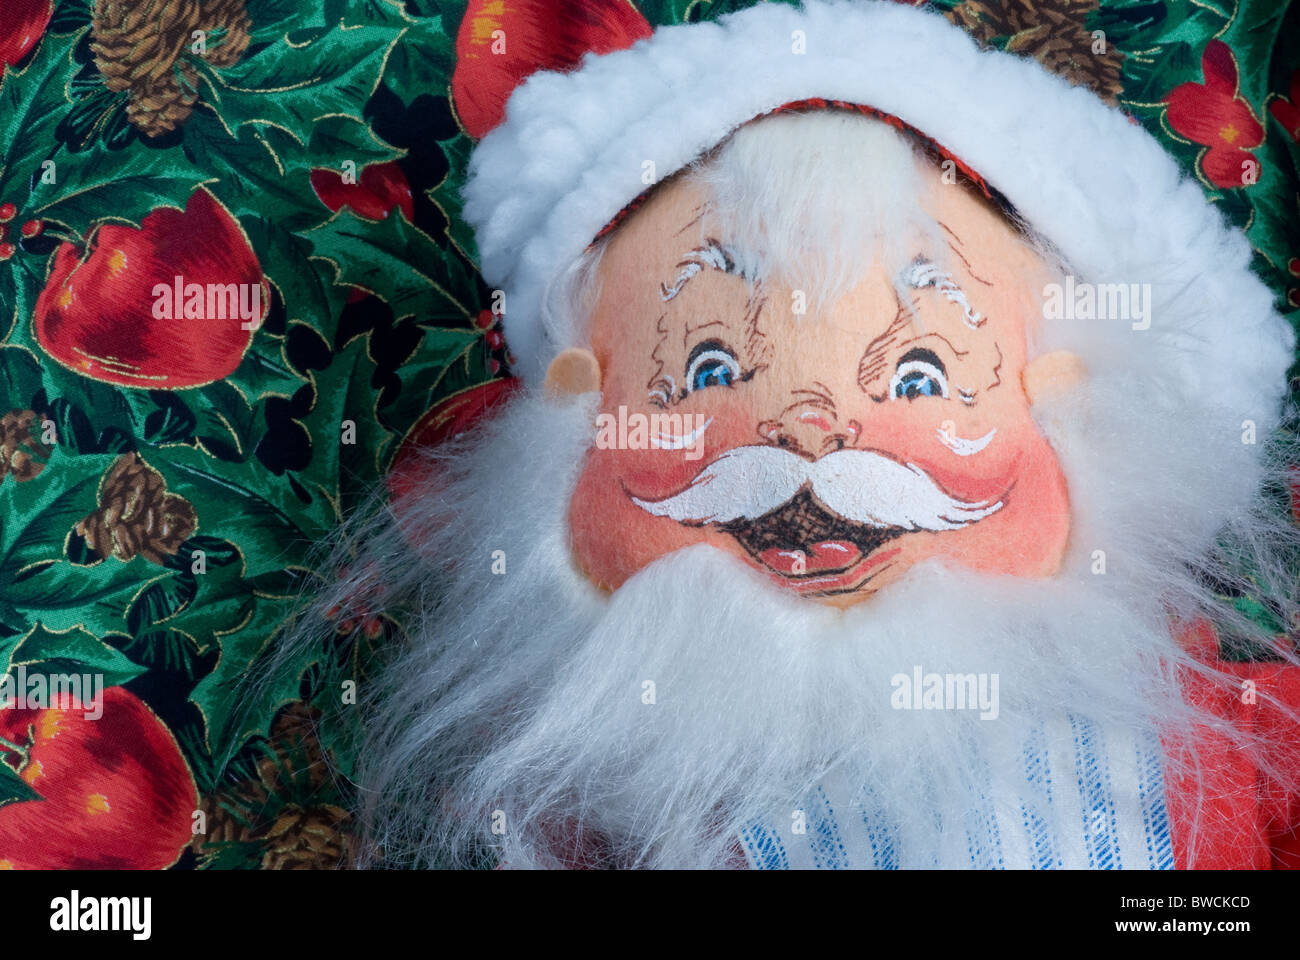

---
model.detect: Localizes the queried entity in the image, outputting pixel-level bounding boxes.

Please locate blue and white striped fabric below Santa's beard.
[741,715,1174,870]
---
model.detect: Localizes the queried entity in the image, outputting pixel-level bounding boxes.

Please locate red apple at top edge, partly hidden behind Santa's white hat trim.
[451,0,651,139]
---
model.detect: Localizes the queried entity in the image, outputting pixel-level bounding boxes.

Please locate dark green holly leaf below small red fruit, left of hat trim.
[306,207,477,323]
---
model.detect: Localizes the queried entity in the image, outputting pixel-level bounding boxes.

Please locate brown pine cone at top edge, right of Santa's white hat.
[945,0,1125,105]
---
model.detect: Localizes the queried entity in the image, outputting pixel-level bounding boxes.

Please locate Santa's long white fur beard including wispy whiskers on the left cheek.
[322,397,1300,868]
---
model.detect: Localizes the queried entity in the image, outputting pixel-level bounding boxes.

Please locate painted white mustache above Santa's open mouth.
[632,445,1002,531]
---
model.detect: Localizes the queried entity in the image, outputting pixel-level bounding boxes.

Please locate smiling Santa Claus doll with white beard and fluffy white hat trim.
[304,0,1300,869]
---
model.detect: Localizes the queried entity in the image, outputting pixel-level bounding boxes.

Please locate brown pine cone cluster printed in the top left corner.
[90,0,252,137]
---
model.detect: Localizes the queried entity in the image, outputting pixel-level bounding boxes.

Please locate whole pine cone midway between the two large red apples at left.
[77,453,198,565]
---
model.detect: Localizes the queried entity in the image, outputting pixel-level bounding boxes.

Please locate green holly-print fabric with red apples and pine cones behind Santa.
[0,0,1300,869]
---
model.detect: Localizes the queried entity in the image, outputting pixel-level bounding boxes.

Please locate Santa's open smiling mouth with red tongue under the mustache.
[719,488,906,593]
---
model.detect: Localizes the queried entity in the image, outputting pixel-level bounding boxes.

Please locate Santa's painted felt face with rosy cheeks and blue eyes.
[569,165,1069,605]
